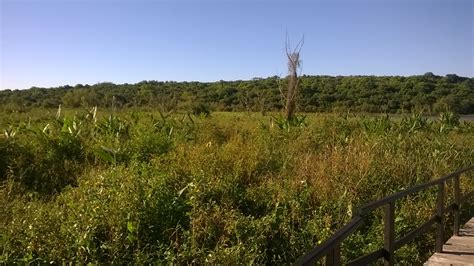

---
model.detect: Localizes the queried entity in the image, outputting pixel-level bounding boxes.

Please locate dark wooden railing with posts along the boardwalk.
[295,165,474,265]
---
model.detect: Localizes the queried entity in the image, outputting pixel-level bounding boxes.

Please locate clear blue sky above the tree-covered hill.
[0,0,474,89]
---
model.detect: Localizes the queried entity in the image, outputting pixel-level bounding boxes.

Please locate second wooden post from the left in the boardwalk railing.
[383,202,395,266]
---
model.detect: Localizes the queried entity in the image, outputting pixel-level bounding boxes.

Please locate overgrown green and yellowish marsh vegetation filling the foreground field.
[0,109,474,264]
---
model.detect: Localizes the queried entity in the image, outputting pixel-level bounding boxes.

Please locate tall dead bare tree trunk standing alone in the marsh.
[285,34,304,120]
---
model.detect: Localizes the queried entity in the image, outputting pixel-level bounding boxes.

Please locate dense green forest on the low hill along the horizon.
[0,72,474,114]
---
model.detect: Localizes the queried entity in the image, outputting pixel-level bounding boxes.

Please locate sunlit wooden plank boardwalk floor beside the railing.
[424,217,474,265]
